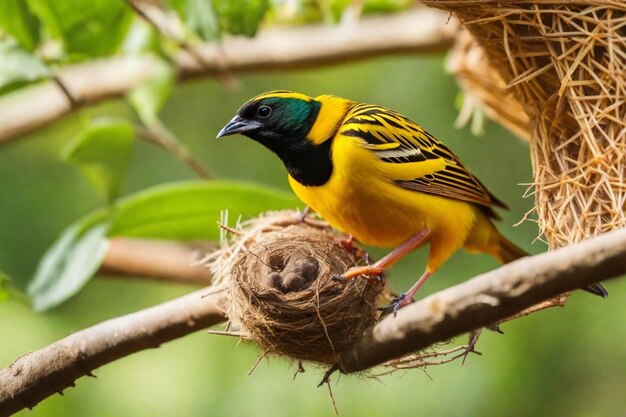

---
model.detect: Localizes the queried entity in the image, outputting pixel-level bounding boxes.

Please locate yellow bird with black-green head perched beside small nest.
[217,90,607,314]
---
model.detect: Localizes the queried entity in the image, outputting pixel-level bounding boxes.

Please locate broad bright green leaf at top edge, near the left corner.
[26,0,132,58]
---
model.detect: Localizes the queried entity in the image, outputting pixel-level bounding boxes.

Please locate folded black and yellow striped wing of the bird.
[339,104,507,217]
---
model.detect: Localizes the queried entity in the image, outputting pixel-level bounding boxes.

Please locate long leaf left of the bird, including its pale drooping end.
[27,181,298,311]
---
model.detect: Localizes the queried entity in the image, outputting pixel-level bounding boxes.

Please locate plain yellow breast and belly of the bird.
[289,135,480,258]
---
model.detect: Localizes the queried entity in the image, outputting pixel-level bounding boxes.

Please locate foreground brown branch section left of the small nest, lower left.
[0,289,224,417]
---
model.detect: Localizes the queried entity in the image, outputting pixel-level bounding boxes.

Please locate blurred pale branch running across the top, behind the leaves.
[0,9,458,144]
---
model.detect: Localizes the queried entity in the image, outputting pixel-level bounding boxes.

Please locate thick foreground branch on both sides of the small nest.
[0,229,626,417]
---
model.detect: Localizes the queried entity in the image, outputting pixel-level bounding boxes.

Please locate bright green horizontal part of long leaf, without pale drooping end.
[109,181,299,240]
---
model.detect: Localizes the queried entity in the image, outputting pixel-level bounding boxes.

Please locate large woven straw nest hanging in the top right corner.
[434,0,626,248]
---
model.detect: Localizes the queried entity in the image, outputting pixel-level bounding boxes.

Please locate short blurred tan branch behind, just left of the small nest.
[99,238,215,285]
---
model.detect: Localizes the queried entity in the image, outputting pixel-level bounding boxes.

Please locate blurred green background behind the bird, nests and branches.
[0,55,626,417]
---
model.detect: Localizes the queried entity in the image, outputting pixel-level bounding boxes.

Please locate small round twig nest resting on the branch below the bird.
[207,212,384,364]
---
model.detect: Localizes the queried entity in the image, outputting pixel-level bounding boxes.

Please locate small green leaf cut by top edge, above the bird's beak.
[212,0,270,36]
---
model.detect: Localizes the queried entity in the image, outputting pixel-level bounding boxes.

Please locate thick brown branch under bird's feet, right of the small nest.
[340,229,626,373]
